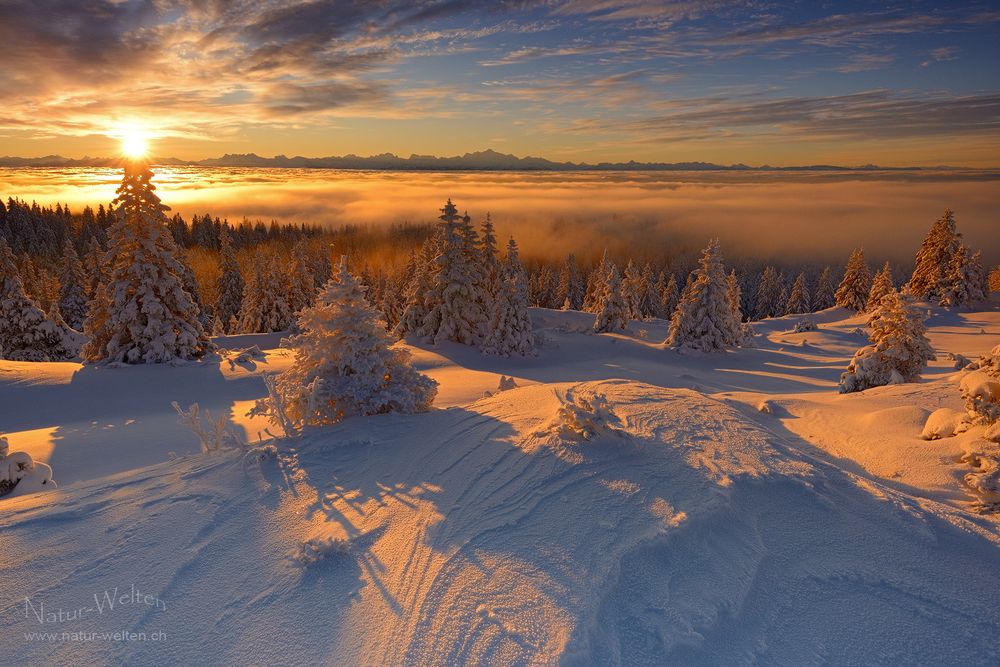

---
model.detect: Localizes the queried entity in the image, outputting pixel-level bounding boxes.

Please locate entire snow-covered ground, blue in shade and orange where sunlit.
[0,309,1000,665]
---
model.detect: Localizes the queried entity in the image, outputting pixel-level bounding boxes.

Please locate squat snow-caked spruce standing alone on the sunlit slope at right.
[840,290,934,394]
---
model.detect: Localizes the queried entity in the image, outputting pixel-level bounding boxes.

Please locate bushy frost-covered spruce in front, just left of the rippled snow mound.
[251,257,437,429]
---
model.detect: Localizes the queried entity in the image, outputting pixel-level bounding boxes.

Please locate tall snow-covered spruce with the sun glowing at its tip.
[83,163,212,364]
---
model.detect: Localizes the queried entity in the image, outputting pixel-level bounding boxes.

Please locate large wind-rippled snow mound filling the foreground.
[0,380,1000,665]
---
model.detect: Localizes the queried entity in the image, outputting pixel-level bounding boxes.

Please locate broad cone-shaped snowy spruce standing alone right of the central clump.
[666,239,743,352]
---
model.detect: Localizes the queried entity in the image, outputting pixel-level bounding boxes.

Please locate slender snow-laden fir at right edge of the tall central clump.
[480,239,535,357]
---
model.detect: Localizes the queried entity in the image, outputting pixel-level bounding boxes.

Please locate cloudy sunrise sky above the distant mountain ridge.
[0,0,1000,167]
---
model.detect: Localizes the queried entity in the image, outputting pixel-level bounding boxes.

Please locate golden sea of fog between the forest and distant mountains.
[0,167,1000,265]
